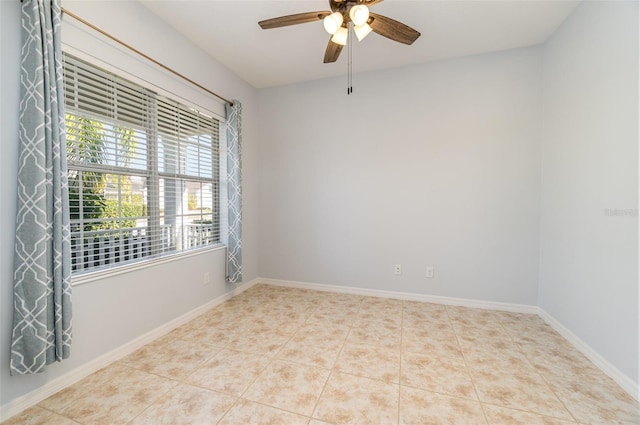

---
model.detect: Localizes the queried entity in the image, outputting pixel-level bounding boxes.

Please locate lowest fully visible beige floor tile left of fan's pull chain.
[243,360,329,416]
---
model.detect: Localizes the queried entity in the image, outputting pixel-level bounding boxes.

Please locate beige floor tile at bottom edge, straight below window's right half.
[129,384,236,425]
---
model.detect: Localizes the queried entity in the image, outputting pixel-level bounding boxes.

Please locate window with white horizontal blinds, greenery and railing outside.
[64,54,220,274]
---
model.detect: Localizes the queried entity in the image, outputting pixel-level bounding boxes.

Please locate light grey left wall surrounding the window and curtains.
[0,1,258,407]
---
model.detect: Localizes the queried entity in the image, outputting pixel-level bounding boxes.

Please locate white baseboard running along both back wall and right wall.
[258,279,640,400]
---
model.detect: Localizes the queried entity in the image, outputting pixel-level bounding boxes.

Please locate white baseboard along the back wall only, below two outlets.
[258,279,538,314]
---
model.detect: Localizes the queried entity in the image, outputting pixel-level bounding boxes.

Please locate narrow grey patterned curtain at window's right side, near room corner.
[225,100,242,283]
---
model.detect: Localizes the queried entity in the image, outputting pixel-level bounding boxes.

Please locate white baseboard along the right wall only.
[538,308,640,400]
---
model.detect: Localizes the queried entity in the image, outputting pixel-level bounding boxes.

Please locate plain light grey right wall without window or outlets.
[539,2,640,383]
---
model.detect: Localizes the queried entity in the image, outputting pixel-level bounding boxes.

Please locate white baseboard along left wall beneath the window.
[0,279,260,421]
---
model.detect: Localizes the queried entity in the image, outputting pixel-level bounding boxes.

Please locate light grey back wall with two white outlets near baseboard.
[259,48,542,305]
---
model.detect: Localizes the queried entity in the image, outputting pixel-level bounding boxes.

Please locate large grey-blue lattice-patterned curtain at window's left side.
[10,0,71,375]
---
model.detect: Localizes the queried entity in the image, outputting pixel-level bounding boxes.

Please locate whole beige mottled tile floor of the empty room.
[4,285,640,425]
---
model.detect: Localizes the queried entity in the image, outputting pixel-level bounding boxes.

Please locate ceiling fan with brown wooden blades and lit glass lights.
[258,0,420,63]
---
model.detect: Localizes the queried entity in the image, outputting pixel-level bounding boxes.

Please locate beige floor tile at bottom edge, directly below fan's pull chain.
[313,372,399,425]
